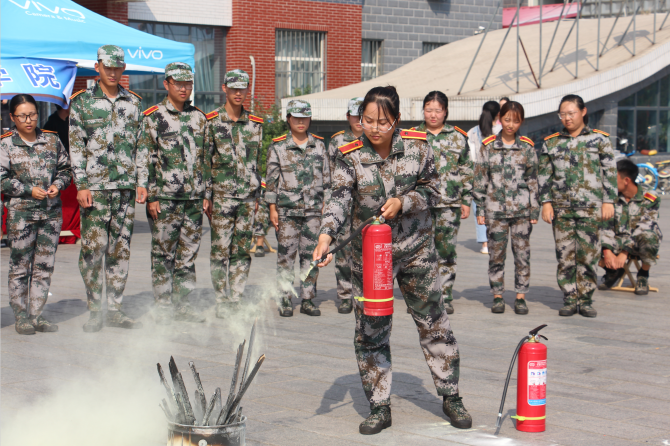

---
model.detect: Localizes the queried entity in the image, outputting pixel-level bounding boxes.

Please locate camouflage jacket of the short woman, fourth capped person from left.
[265,131,330,217]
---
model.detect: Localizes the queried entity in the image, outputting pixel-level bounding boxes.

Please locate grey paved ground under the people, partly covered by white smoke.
[0,203,670,446]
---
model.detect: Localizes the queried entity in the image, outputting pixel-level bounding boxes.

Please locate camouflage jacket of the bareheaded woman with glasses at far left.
[0,129,71,220]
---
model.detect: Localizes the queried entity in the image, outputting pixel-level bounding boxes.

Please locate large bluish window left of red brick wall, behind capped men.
[128,21,226,112]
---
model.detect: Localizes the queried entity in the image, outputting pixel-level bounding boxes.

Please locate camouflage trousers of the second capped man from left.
[147,199,203,306]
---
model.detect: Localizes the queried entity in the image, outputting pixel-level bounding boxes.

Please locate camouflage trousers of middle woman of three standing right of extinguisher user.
[486,217,533,294]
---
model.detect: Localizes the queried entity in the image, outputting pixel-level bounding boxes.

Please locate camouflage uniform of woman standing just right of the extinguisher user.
[418,123,473,301]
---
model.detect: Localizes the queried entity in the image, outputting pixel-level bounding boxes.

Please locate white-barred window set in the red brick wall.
[275,29,326,101]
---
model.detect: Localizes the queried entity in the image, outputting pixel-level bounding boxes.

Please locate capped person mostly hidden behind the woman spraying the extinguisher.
[328,98,363,314]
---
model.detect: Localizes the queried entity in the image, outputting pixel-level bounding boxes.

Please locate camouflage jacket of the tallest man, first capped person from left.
[70,83,142,190]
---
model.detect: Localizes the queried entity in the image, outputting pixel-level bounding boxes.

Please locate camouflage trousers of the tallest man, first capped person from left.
[79,189,135,311]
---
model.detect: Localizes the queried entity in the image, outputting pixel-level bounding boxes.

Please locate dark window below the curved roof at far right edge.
[617,75,670,152]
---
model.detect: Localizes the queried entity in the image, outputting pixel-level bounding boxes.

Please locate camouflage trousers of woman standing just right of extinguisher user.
[431,207,461,301]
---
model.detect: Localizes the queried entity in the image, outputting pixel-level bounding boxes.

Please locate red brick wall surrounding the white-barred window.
[226,0,362,105]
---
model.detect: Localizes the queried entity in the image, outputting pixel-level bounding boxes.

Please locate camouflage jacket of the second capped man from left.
[137,97,211,202]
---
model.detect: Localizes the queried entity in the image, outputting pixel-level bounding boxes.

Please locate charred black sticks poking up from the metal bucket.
[157,322,265,426]
